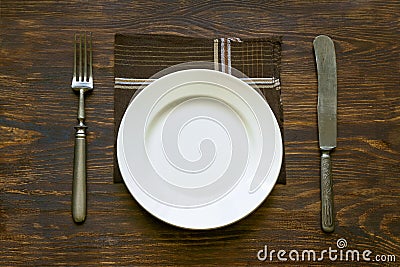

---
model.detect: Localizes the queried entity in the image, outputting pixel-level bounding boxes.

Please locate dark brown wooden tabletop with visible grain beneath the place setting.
[0,0,400,266]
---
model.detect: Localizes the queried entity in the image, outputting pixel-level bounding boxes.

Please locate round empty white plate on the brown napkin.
[117,69,282,229]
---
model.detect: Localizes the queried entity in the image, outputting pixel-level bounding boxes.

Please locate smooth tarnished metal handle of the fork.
[72,125,86,223]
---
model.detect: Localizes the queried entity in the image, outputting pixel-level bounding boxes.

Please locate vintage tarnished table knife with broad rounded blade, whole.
[313,35,337,233]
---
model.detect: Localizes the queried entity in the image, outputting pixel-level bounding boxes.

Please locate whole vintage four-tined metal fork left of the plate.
[71,32,93,223]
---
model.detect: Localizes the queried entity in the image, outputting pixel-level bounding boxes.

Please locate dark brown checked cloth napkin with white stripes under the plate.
[114,34,286,184]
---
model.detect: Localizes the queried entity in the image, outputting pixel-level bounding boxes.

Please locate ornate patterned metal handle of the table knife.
[321,150,335,233]
